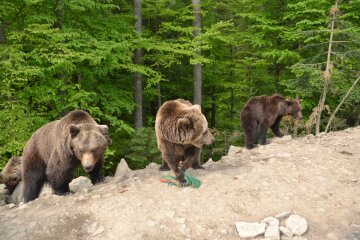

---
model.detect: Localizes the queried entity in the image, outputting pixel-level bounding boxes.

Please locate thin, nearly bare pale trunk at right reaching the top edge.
[316,1,338,135]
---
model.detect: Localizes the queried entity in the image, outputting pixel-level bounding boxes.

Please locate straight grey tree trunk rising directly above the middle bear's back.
[192,0,202,106]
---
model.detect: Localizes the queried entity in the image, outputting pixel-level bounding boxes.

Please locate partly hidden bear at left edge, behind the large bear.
[0,157,21,195]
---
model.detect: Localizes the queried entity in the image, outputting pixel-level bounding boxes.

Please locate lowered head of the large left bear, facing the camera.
[70,124,111,172]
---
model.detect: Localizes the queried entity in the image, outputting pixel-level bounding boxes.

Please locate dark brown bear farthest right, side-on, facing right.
[240,94,302,149]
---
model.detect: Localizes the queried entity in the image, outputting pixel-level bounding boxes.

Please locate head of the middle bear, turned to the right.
[176,105,215,148]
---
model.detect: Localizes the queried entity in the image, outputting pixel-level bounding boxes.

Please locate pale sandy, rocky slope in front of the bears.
[0,127,360,240]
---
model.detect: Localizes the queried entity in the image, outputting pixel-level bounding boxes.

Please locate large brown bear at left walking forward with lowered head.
[22,110,111,202]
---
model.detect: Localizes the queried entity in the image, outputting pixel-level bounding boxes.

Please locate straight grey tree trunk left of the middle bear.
[134,0,143,130]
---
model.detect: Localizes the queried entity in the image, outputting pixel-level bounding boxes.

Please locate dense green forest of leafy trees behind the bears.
[0,0,360,174]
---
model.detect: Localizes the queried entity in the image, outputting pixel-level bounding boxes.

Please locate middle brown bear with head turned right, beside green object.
[155,99,215,185]
